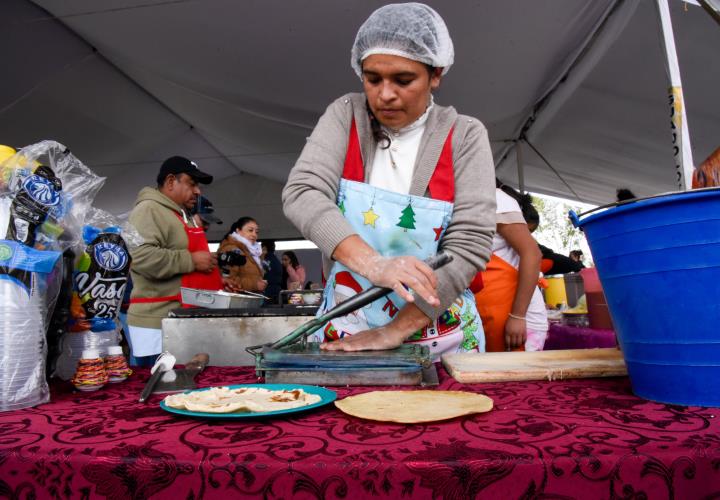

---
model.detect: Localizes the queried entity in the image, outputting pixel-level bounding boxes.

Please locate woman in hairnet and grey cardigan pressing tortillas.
[283,3,495,357]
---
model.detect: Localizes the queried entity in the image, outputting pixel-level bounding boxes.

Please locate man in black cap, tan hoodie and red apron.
[128,156,222,366]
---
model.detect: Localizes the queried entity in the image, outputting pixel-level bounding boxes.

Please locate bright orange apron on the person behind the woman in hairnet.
[475,254,525,352]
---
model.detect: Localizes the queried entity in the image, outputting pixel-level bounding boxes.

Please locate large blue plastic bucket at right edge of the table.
[570,188,720,406]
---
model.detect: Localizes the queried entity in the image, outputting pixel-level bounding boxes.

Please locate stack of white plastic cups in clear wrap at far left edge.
[0,275,50,411]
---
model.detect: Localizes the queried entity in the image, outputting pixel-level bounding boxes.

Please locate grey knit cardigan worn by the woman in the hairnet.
[283,94,495,319]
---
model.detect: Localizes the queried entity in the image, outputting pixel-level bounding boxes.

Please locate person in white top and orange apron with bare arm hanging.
[475,184,548,352]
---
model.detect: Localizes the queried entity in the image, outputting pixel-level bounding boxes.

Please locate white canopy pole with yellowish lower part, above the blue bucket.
[655,0,695,190]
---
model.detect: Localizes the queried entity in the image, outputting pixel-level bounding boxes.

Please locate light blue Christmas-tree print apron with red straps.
[315,120,485,358]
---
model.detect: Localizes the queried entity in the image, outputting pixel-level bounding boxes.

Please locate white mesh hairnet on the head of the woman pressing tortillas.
[350,2,455,78]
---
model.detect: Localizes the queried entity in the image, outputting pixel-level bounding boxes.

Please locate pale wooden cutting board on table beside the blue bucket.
[442,347,627,383]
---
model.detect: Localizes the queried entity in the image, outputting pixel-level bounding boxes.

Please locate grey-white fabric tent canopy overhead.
[0,0,720,242]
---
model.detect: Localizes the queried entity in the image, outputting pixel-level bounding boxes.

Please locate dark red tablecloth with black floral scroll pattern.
[0,367,720,499]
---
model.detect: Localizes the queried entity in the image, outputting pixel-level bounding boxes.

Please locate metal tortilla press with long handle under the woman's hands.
[246,252,452,386]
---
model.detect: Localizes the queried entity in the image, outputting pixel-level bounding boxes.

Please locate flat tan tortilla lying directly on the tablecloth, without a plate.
[335,391,492,424]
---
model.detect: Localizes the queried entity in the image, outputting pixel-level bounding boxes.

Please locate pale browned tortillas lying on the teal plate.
[164,387,321,413]
